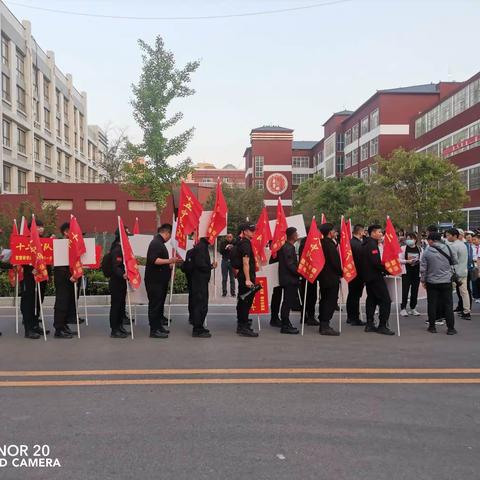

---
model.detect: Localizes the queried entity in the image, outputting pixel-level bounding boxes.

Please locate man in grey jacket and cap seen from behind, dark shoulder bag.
[420,232,458,335]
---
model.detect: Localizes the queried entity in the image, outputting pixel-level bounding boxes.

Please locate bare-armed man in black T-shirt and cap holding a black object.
[236,223,258,337]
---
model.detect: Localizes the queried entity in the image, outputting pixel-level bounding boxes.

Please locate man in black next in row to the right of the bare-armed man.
[278,227,299,334]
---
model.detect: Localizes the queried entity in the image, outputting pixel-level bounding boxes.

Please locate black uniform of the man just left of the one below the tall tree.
[108,241,127,332]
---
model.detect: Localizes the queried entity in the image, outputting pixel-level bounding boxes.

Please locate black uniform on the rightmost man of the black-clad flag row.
[362,238,392,327]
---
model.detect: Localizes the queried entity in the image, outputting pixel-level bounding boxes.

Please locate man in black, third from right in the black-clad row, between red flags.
[318,223,343,336]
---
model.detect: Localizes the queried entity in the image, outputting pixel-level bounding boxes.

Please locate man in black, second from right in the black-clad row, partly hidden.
[347,224,365,326]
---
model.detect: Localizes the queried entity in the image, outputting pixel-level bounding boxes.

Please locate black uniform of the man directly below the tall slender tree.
[145,234,171,331]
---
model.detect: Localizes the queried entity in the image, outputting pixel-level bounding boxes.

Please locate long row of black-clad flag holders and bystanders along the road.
[2,221,480,339]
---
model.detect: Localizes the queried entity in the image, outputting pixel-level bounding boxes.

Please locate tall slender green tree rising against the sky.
[124,35,200,222]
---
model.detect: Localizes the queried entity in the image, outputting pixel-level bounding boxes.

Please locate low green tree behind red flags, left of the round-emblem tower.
[205,183,263,234]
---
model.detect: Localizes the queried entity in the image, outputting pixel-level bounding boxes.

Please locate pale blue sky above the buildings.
[5,0,480,168]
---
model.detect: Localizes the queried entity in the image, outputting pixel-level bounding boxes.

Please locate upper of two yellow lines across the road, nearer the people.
[0,368,480,377]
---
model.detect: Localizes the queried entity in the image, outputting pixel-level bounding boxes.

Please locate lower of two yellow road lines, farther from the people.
[0,377,480,388]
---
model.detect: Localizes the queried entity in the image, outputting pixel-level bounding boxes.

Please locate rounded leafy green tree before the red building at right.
[368,149,468,231]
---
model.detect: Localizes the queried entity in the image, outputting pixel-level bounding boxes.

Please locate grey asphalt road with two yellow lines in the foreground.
[0,304,480,480]
